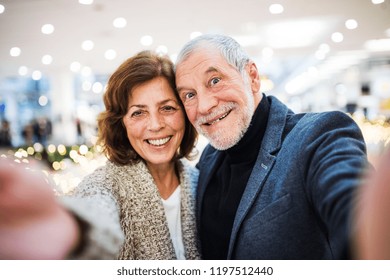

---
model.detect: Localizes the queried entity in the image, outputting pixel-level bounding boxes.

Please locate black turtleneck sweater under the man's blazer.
[200,94,269,260]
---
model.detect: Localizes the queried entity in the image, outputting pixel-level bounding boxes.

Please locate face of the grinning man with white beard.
[176,48,259,150]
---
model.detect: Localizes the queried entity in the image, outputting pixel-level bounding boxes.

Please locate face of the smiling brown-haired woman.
[123,77,185,165]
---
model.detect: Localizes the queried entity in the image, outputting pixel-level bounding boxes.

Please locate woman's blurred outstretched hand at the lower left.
[0,159,80,259]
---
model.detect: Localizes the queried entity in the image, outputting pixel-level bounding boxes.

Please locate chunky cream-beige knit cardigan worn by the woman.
[61,160,200,260]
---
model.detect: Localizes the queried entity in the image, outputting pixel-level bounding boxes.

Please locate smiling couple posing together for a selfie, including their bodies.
[0,34,380,259]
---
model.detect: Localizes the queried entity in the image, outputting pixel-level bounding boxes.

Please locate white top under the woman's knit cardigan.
[161,185,185,260]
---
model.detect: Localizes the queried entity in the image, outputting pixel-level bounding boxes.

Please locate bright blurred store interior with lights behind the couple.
[0,0,390,190]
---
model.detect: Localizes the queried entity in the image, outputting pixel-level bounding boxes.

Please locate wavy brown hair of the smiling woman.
[98,51,197,165]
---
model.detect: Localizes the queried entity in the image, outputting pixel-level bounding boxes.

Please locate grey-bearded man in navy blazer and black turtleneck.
[176,34,368,259]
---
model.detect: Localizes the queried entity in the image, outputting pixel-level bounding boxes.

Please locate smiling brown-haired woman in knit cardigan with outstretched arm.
[0,51,200,259]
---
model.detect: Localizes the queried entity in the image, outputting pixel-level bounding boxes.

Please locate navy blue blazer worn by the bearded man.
[196,96,367,260]
